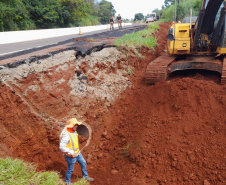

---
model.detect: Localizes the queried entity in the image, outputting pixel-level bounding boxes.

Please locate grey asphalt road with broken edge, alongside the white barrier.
[0,24,147,65]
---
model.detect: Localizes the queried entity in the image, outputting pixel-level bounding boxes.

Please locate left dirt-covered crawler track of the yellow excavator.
[145,55,175,84]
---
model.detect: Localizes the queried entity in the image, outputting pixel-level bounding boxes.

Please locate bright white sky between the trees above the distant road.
[107,0,164,19]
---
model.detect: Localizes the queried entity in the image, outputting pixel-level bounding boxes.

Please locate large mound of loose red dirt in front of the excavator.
[83,24,226,185]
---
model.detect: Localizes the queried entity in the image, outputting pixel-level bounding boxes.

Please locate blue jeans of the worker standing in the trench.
[64,153,88,183]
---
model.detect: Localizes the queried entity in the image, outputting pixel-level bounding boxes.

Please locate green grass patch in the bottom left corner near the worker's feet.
[0,157,87,185]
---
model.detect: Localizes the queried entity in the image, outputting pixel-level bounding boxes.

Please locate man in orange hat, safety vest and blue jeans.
[60,118,94,184]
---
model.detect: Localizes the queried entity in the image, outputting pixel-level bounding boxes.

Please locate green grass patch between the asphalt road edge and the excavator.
[115,22,159,49]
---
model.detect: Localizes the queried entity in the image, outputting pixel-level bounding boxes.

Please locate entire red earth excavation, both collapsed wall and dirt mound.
[0,23,226,185]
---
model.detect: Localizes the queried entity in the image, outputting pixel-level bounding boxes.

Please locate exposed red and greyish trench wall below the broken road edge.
[0,48,131,170]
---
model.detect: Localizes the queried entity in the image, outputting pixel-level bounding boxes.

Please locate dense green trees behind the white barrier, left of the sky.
[0,0,116,31]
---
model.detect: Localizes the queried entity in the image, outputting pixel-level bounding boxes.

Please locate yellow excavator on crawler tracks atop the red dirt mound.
[145,0,226,84]
